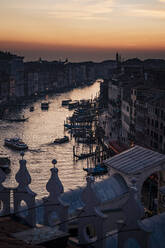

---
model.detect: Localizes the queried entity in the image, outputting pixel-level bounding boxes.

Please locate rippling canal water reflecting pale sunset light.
[0,82,100,198]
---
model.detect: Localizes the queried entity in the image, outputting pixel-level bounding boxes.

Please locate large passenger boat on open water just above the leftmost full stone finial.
[4,138,28,150]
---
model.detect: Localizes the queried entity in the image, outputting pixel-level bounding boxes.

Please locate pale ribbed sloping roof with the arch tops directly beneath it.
[104,145,165,194]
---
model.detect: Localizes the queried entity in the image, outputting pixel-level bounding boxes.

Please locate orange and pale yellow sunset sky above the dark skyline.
[0,0,165,61]
